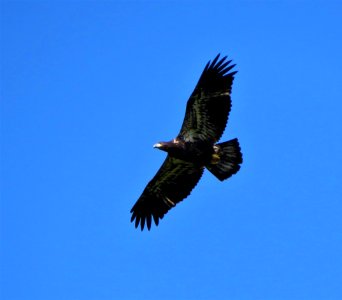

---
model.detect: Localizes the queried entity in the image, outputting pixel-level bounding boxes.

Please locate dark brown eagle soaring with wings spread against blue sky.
[131,54,242,230]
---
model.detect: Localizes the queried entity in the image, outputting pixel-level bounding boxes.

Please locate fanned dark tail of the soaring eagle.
[206,139,242,181]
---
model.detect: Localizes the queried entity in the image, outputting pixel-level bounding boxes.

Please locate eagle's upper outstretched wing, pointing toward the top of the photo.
[178,54,237,143]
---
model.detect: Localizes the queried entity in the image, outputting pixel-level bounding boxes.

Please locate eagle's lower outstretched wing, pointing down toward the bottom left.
[131,155,203,230]
